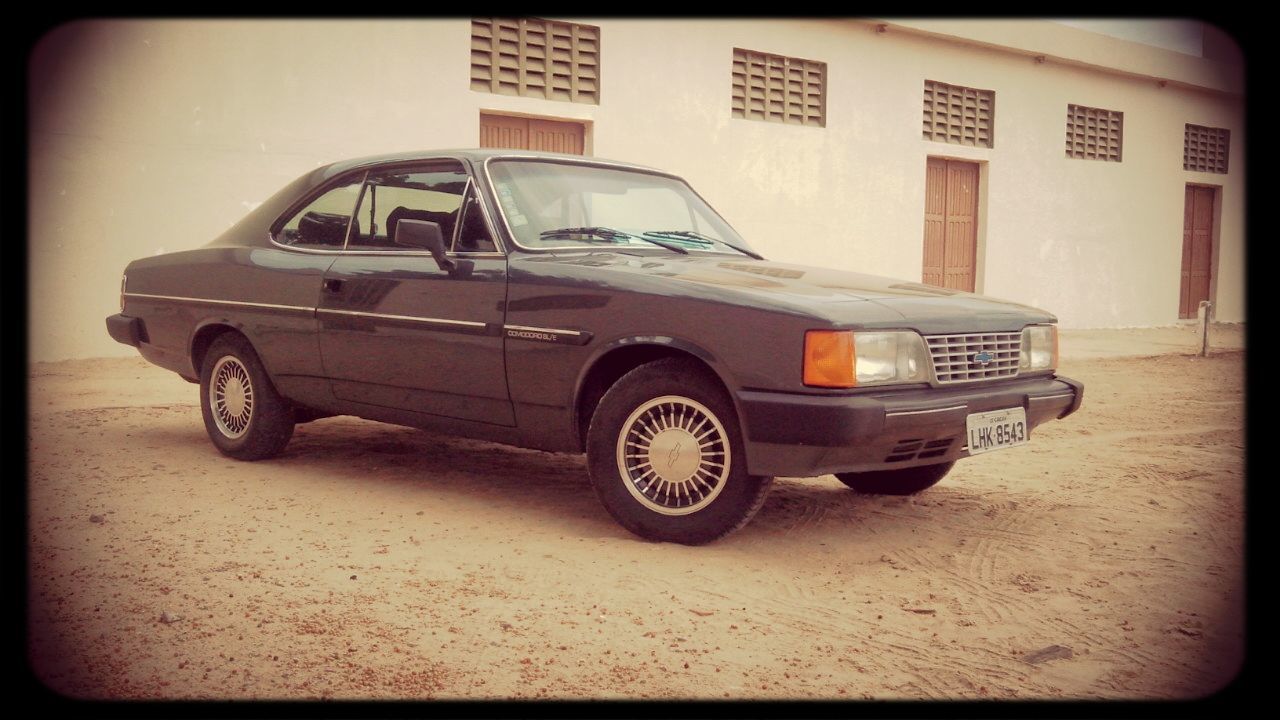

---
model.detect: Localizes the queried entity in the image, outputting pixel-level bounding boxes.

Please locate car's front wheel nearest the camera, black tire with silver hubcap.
[586,359,773,544]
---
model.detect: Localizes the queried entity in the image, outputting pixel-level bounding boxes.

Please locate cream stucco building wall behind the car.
[28,19,1247,360]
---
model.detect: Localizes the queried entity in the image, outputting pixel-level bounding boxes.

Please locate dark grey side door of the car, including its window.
[317,160,515,425]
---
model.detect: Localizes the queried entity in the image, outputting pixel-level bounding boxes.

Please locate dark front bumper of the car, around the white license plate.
[737,375,1084,478]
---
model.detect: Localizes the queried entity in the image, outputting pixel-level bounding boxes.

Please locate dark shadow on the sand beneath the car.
[135,416,978,544]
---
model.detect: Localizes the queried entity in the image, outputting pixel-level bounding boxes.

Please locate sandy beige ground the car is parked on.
[27,327,1245,698]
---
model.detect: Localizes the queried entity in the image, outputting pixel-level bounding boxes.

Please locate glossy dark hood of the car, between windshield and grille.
[524,251,1056,332]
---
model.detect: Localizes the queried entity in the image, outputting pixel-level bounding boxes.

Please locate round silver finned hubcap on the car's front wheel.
[617,395,730,515]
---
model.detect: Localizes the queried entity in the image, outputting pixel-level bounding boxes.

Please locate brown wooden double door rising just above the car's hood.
[922,158,978,292]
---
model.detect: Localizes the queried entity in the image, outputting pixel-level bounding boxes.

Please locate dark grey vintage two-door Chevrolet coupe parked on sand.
[106,150,1083,543]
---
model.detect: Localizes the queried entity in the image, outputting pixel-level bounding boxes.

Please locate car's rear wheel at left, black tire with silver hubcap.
[200,333,293,460]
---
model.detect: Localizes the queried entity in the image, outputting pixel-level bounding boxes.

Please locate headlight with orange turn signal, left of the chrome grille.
[804,331,929,387]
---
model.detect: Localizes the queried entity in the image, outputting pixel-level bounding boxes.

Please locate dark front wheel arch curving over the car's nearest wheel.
[572,336,742,451]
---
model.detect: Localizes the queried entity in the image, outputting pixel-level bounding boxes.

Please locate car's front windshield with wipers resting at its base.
[489,160,749,255]
